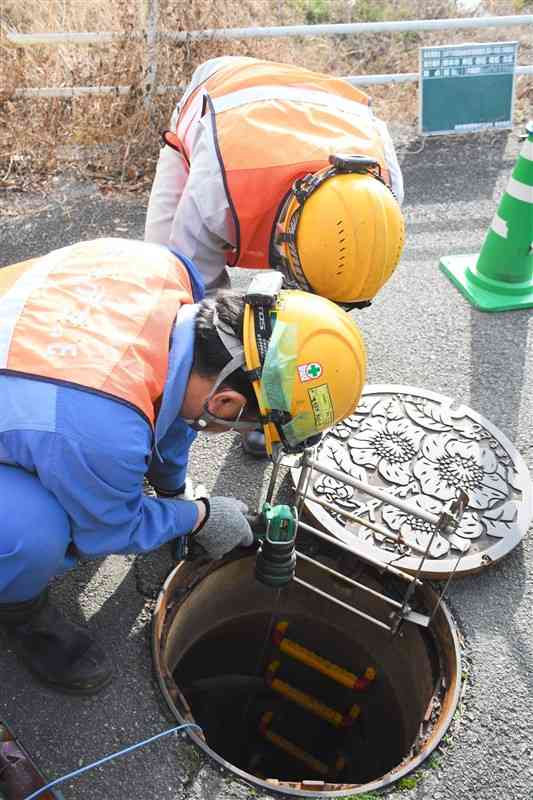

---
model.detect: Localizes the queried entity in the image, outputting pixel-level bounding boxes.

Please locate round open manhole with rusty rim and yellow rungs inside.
[153,553,461,797]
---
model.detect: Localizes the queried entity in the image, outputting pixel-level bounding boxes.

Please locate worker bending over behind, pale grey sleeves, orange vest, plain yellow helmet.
[145,57,404,456]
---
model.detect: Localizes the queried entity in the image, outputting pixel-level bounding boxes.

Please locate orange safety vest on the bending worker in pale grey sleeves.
[164,58,390,269]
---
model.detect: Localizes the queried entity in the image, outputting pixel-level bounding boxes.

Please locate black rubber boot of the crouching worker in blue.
[0,592,112,695]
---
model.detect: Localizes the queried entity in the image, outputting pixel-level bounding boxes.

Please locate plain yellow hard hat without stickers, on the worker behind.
[272,156,405,306]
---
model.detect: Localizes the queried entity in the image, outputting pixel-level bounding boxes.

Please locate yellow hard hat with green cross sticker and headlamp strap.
[242,275,366,455]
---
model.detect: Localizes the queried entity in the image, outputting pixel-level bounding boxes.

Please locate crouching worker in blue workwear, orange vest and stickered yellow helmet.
[0,239,365,694]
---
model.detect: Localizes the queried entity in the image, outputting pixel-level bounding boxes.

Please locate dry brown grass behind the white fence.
[0,0,533,194]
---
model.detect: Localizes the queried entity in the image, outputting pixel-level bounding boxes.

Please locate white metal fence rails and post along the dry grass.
[6,13,533,100]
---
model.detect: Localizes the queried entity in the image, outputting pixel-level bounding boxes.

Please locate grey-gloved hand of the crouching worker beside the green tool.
[192,497,254,558]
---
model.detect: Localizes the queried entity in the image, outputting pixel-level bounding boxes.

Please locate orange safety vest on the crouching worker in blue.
[0,239,193,425]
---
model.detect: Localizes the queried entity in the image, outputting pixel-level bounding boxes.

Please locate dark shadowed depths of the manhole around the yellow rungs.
[174,614,414,783]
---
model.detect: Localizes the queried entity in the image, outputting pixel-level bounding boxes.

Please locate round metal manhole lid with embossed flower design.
[292,384,533,578]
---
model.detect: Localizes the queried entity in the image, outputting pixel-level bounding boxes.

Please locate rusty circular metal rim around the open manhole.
[151,554,462,800]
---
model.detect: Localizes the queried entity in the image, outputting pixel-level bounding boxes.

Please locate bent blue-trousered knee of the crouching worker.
[0,465,70,602]
